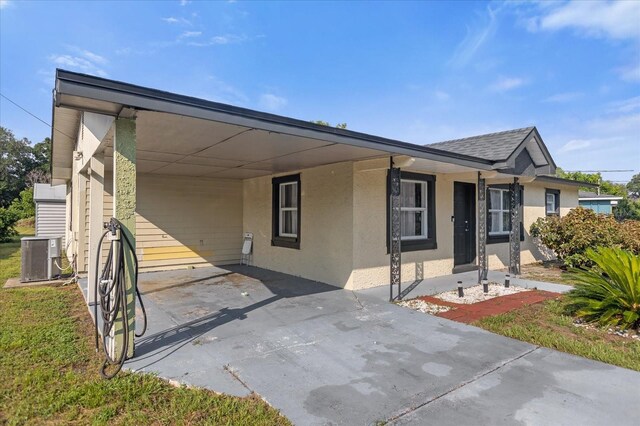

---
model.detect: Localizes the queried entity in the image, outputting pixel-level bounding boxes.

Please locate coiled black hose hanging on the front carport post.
[93,218,147,379]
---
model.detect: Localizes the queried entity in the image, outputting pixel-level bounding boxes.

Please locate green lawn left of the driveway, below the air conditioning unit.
[0,228,290,425]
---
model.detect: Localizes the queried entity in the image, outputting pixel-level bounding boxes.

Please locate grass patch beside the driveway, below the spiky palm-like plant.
[474,298,640,371]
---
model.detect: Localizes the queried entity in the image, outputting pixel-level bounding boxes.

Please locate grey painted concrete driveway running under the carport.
[127,267,640,425]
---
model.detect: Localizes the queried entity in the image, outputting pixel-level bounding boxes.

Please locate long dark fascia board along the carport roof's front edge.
[55,70,493,170]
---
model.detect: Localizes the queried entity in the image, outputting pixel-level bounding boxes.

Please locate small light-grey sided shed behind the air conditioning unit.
[33,183,67,244]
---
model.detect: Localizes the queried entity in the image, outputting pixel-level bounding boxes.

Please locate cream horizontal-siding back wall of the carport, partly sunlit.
[92,173,242,271]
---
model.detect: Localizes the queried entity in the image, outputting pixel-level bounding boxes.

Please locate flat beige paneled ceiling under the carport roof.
[104,111,389,179]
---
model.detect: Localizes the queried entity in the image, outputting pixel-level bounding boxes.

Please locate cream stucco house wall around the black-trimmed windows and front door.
[244,159,578,289]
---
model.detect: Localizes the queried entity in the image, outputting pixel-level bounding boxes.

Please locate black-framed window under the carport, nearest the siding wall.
[271,174,301,248]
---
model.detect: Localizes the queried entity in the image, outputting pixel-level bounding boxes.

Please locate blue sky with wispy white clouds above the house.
[0,0,640,181]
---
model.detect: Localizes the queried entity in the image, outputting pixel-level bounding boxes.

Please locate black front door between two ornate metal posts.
[453,182,476,265]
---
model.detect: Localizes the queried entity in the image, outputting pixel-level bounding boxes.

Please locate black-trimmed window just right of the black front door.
[487,185,524,244]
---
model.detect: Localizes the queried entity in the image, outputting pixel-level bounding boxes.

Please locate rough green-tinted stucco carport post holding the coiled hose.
[113,118,136,358]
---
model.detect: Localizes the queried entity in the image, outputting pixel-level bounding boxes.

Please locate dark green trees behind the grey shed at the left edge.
[0,127,51,207]
